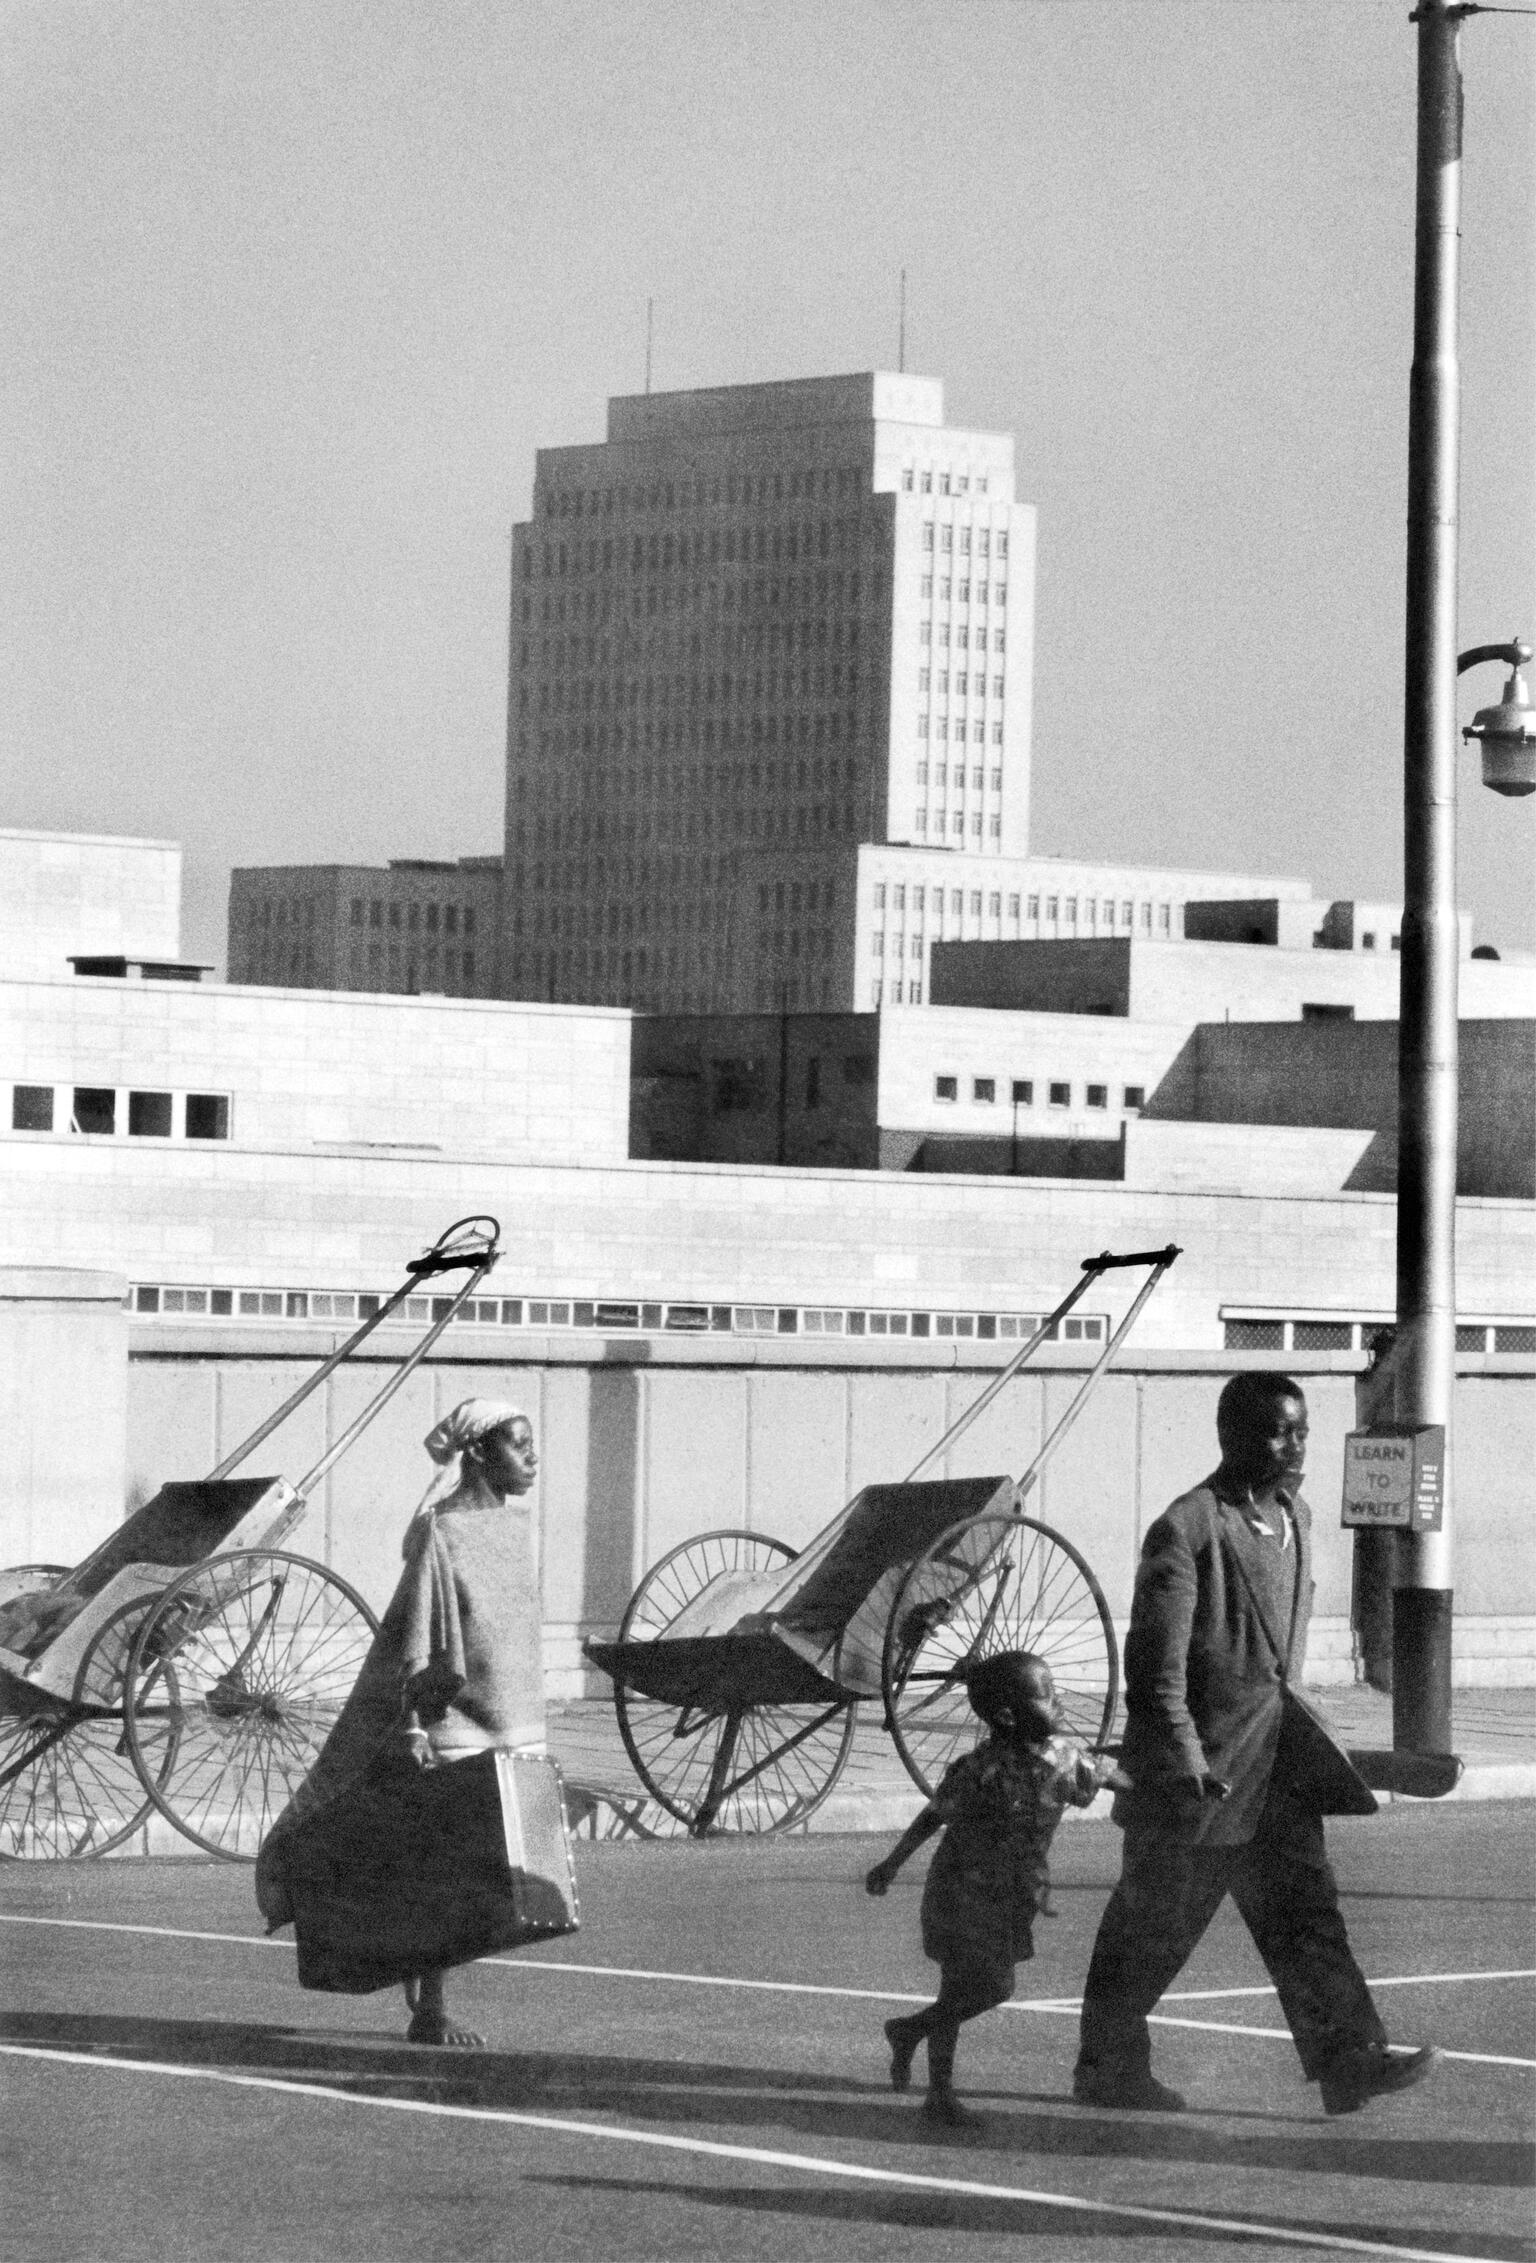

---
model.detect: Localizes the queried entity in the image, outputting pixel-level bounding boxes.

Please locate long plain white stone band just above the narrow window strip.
[0,1138,1536,1349]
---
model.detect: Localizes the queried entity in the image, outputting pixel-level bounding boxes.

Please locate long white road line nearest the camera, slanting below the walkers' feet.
[0,2043,1495,2263]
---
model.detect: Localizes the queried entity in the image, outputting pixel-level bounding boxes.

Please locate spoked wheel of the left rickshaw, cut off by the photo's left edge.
[0,1593,172,1862]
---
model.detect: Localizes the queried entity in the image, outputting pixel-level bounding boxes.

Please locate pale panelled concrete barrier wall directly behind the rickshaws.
[127,1340,1536,1697]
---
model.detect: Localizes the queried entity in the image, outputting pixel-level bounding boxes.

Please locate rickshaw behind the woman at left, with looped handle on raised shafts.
[0,1217,500,1860]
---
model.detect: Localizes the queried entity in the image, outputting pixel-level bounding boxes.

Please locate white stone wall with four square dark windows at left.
[0,978,629,1170]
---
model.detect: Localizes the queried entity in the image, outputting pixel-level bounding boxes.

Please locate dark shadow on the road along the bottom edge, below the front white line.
[525,2166,1536,2263]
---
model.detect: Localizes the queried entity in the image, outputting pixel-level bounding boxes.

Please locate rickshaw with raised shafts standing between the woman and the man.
[586,1245,1179,1838]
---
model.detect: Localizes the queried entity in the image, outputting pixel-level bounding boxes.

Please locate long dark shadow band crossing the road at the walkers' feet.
[0,2012,1536,2188]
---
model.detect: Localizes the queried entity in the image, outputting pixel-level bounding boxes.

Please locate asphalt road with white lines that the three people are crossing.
[0,1804,1536,2263]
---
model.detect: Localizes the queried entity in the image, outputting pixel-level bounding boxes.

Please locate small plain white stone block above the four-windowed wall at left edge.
[0,831,181,978]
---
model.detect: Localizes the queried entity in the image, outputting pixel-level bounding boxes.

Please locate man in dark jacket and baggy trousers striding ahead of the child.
[1072,1374,1436,2114]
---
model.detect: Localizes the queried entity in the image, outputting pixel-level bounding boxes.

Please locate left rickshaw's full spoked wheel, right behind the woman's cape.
[127,1548,378,1862]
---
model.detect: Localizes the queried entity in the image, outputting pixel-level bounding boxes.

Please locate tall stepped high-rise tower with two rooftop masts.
[504,373,1034,1009]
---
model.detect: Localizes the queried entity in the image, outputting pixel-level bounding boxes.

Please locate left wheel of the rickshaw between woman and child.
[613,1532,853,1838]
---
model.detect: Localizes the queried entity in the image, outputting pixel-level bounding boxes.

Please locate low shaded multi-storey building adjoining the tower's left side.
[228,855,502,998]
